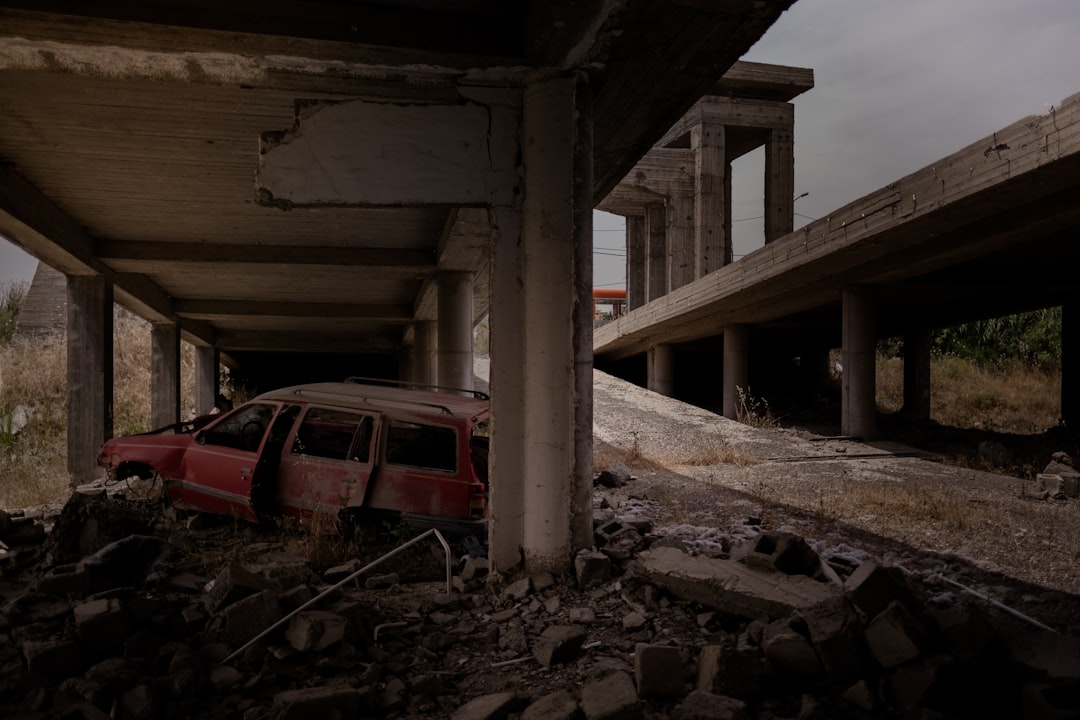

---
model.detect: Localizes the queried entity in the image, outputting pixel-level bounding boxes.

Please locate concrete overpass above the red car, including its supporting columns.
[0,0,794,571]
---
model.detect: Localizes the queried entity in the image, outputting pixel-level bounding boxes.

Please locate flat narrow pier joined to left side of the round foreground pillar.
[487,208,525,572]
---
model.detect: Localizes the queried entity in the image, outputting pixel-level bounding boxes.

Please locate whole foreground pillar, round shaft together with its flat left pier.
[490,78,593,573]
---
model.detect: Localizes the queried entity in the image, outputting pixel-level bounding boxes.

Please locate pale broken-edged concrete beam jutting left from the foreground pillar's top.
[256,100,518,207]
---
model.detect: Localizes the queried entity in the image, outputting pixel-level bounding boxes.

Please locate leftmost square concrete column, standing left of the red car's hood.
[67,275,112,487]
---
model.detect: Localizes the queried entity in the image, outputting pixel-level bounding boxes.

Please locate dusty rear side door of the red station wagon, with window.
[278,406,379,517]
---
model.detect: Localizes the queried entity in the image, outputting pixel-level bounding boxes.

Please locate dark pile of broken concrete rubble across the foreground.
[0,480,1080,720]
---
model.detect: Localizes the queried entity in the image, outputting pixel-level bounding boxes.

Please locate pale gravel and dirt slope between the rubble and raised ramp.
[594,372,1080,629]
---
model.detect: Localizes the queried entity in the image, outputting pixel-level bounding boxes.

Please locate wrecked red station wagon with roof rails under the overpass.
[98,378,489,535]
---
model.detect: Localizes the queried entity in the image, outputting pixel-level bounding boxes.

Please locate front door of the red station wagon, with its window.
[170,403,280,520]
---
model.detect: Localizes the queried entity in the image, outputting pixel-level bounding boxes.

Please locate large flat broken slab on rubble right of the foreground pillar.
[635,547,841,620]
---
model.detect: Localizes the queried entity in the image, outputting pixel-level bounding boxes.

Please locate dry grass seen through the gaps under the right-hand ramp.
[877,357,1062,435]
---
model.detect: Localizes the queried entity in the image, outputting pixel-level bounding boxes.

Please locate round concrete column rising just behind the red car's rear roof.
[437,272,473,390]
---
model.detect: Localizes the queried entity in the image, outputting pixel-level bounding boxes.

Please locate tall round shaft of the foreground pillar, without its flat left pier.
[521,79,593,574]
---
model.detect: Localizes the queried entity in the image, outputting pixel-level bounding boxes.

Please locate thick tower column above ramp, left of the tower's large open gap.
[690,121,730,280]
